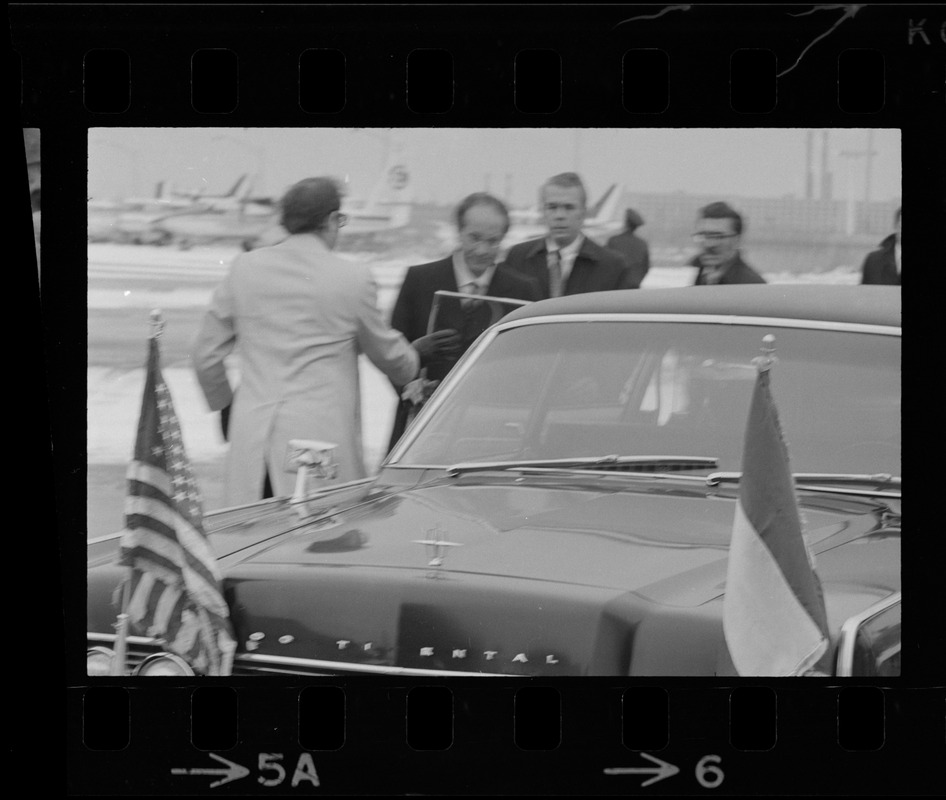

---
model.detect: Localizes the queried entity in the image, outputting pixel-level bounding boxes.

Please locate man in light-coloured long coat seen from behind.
[193,177,421,506]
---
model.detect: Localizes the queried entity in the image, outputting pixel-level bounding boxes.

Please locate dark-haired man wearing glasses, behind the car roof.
[690,202,765,286]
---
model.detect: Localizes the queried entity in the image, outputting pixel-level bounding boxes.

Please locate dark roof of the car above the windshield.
[503,284,900,328]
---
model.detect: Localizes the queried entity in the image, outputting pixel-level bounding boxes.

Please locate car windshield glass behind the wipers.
[394,321,900,475]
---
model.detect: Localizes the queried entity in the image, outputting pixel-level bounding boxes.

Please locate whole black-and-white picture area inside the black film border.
[87,127,910,678]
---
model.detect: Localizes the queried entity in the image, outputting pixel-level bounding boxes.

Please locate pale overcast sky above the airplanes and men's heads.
[88,128,901,206]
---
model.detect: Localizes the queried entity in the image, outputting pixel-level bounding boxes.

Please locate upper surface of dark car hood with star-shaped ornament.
[232,477,877,592]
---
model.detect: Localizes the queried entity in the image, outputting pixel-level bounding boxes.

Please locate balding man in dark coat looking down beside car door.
[388,192,540,450]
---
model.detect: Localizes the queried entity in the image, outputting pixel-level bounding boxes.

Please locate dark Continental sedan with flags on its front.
[88,285,900,676]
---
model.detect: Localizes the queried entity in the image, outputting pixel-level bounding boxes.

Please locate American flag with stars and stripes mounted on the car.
[118,336,236,675]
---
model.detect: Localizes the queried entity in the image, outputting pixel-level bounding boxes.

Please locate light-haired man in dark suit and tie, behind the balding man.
[502,172,636,299]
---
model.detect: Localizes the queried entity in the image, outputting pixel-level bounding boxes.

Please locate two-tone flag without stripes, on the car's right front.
[723,366,829,677]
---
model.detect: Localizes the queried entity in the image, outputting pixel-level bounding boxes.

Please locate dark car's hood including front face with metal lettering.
[88,474,899,675]
